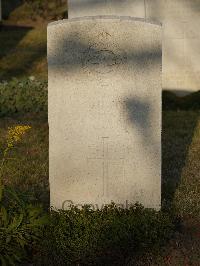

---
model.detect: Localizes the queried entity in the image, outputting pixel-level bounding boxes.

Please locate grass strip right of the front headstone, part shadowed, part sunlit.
[162,111,200,217]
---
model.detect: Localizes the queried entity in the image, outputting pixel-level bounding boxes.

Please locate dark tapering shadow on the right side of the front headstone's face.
[124,97,161,178]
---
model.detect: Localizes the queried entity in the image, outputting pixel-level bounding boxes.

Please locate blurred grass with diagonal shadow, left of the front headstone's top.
[0,25,47,80]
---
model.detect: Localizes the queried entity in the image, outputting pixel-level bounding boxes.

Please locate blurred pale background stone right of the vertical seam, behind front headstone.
[146,0,200,94]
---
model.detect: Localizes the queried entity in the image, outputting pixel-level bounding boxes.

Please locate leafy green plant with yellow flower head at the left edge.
[0,125,46,266]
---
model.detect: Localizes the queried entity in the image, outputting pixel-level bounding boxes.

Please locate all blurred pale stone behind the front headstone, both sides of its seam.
[68,0,200,95]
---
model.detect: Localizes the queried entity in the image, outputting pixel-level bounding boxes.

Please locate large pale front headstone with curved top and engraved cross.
[48,16,162,209]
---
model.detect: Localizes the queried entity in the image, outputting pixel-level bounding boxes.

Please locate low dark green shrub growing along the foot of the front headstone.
[34,203,175,265]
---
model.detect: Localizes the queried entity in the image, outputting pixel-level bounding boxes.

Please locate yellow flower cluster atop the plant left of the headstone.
[7,126,31,148]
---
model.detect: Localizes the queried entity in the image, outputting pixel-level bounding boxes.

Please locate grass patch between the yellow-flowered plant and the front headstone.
[0,116,49,207]
